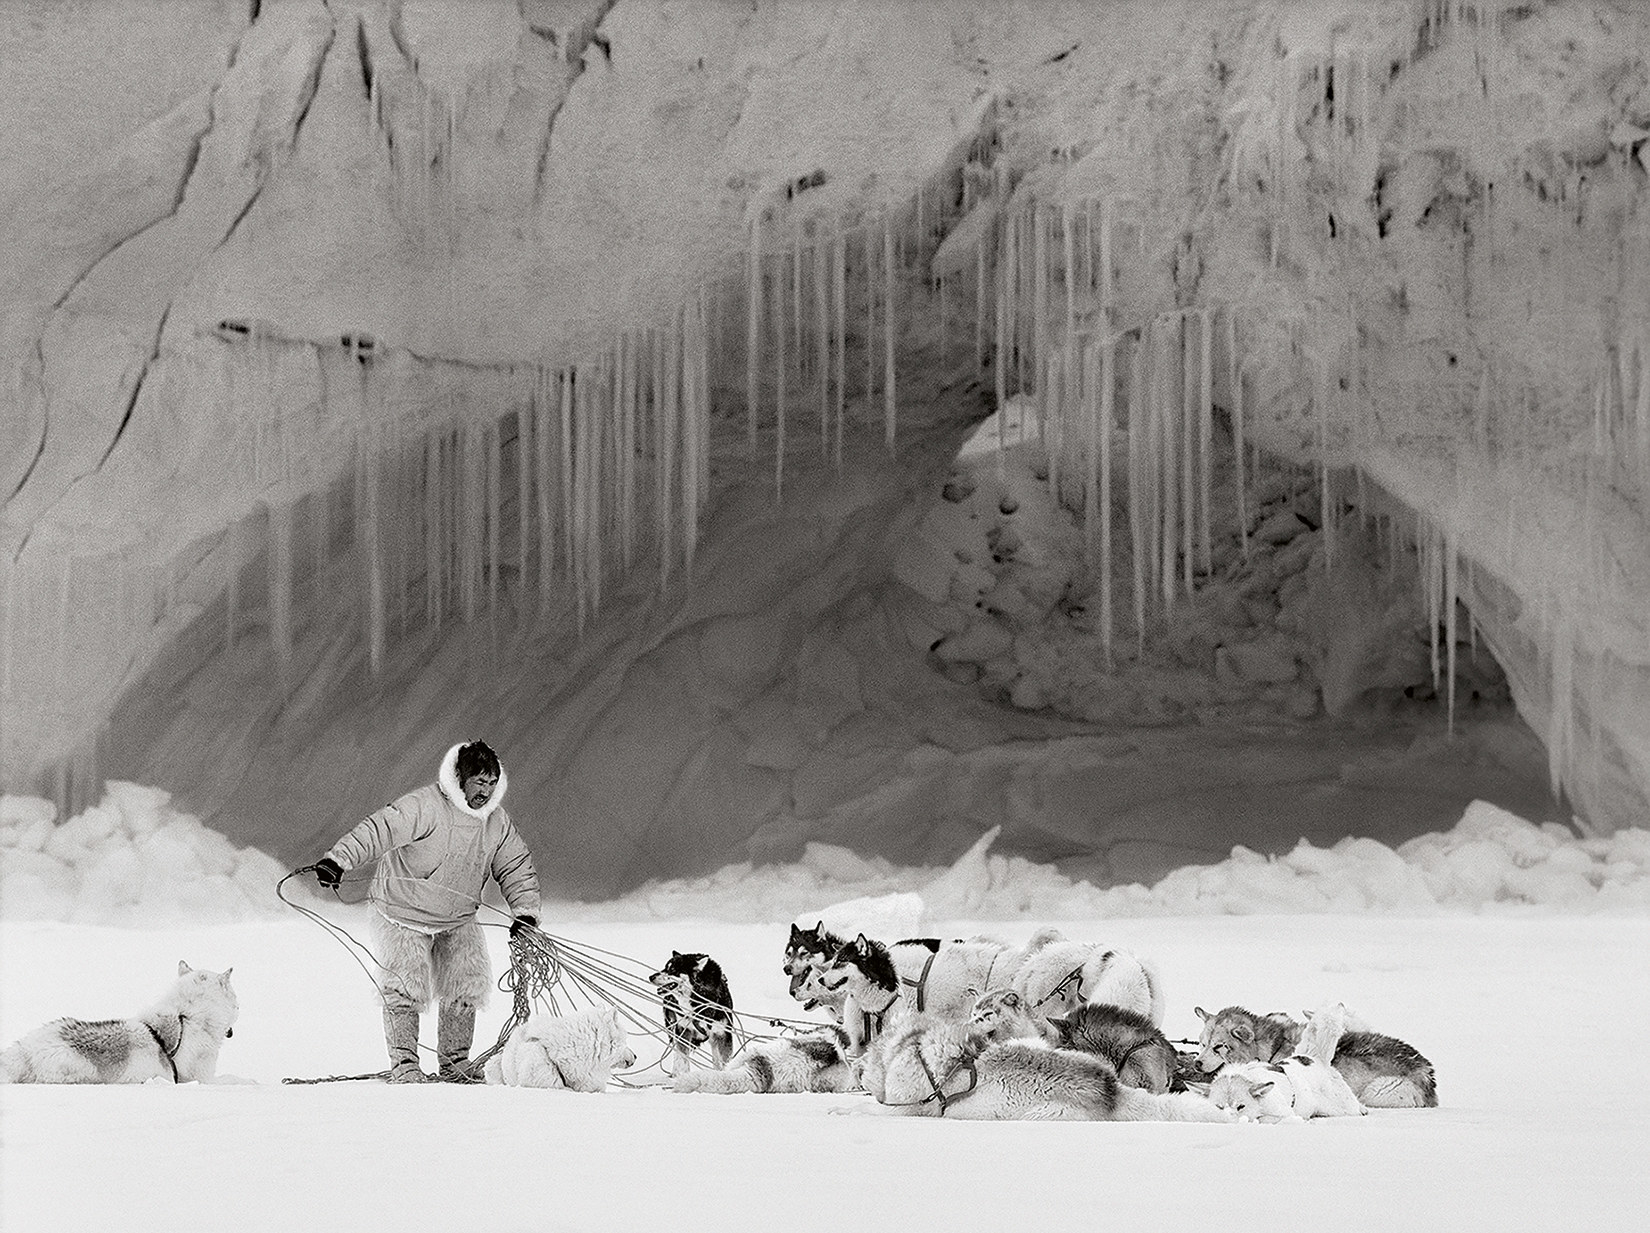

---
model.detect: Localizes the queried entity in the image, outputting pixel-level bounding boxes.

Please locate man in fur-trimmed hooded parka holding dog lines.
[314,741,540,1083]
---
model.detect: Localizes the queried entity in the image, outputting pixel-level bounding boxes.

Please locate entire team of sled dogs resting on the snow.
[0,924,1437,1122]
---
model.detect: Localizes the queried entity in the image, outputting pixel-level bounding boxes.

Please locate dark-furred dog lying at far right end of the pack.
[1195,1004,1439,1109]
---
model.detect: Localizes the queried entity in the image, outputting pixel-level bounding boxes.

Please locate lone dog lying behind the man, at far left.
[0,961,241,1083]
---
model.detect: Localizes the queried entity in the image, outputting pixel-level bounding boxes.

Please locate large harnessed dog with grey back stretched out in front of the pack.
[861,1013,1233,1122]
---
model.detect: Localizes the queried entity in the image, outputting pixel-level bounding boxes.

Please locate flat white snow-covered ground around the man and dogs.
[0,789,1650,1233]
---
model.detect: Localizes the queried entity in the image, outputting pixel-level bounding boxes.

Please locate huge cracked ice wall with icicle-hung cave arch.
[0,0,1650,900]
